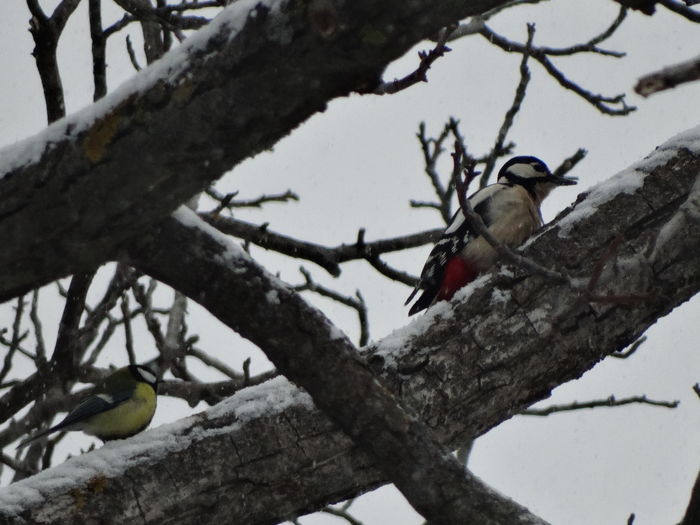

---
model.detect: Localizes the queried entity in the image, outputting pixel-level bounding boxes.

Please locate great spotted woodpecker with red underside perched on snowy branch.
[406,156,576,315]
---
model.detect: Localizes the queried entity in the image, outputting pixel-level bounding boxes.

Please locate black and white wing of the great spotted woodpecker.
[405,184,507,315]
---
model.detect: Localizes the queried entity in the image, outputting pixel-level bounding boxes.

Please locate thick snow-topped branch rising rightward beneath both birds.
[0,133,700,525]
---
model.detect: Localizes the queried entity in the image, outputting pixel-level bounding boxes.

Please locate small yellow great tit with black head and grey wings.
[17,365,158,448]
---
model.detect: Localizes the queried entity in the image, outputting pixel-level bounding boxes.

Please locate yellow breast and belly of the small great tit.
[83,383,157,441]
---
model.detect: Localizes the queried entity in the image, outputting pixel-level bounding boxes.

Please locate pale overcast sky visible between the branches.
[0,0,700,525]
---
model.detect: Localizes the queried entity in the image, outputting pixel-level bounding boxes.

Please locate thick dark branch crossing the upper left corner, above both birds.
[0,0,503,300]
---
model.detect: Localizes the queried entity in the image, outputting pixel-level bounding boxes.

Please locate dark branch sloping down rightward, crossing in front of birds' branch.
[132,211,543,525]
